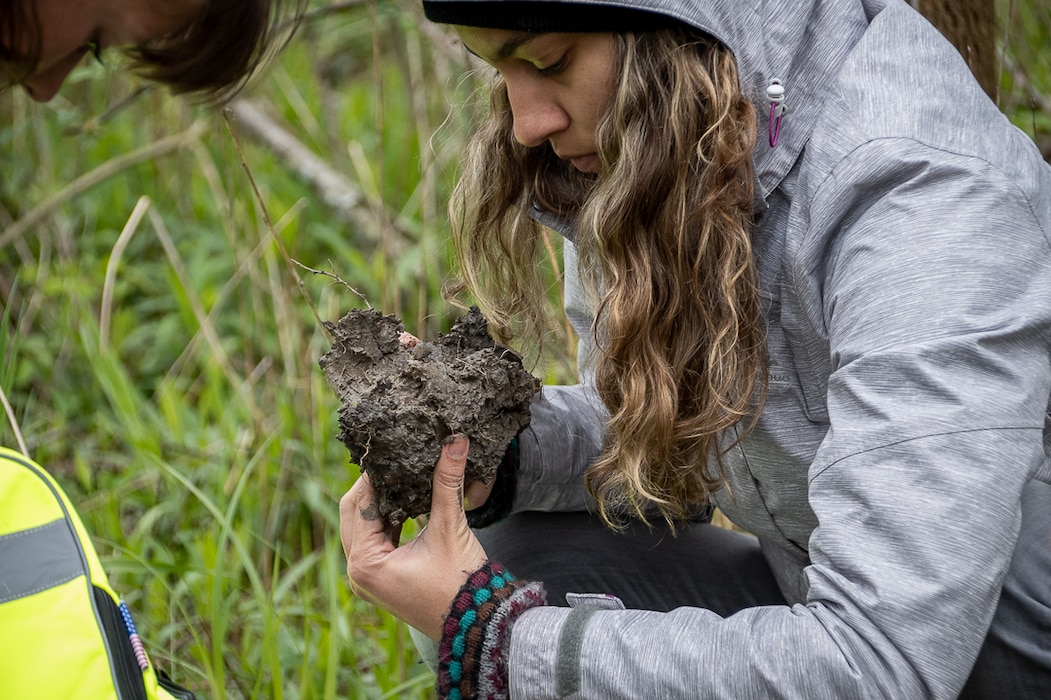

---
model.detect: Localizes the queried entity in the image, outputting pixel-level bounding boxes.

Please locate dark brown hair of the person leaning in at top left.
[0,0,305,97]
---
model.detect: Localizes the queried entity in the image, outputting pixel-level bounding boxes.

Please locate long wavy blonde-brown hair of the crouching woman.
[450,26,766,527]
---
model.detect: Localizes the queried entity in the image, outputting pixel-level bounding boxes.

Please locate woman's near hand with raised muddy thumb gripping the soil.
[339,435,488,640]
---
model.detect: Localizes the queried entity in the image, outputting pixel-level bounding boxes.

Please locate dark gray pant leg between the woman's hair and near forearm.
[475,512,784,616]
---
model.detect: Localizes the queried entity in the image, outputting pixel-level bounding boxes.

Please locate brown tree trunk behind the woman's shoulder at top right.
[912,0,1000,101]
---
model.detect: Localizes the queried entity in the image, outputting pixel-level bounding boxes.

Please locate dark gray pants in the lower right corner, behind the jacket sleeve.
[960,481,1051,700]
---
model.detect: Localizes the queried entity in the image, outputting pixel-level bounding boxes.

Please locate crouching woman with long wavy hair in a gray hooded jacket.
[341,0,1051,699]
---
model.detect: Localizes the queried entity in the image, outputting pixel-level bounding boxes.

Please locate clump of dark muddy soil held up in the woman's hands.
[321,307,540,524]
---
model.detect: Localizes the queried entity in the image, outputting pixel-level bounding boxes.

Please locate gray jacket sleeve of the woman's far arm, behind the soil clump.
[513,241,607,511]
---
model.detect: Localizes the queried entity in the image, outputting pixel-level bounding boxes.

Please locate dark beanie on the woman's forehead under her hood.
[424,0,676,33]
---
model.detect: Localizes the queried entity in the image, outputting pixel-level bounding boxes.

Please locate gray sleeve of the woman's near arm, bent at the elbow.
[509,142,1051,700]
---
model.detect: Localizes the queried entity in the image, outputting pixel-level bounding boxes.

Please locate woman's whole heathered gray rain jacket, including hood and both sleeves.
[433,0,1051,700]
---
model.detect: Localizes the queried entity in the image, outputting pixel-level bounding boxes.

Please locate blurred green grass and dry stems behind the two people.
[0,0,1051,699]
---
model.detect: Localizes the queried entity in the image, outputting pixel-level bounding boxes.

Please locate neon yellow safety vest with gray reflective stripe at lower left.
[0,448,194,700]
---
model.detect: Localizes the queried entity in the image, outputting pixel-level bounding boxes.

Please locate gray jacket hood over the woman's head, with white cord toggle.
[426,0,894,206]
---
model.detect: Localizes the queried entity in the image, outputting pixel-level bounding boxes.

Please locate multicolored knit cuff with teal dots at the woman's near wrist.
[437,561,547,700]
